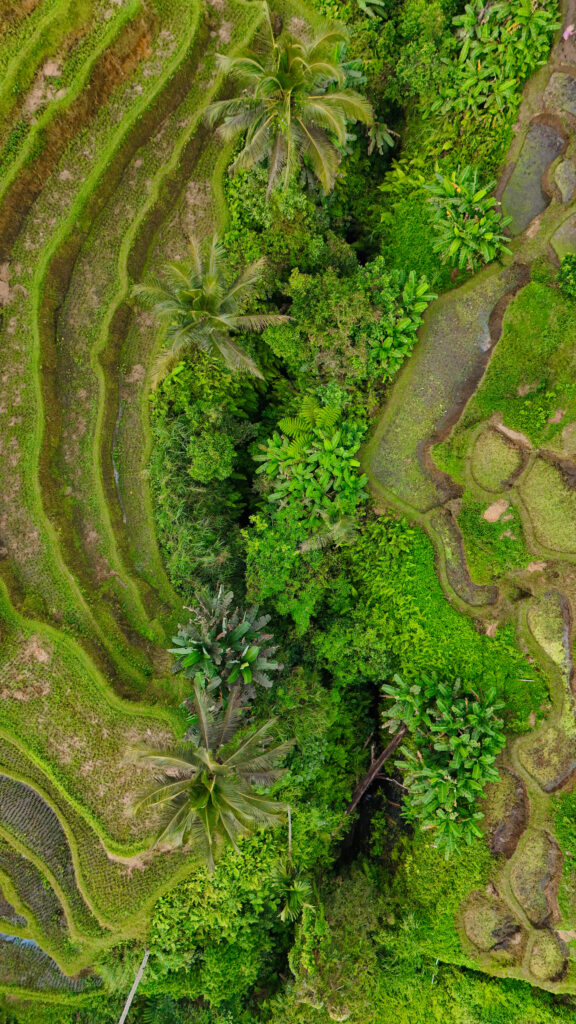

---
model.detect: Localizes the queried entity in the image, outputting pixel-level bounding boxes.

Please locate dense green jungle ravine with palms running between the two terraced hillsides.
[10,0,576,1024]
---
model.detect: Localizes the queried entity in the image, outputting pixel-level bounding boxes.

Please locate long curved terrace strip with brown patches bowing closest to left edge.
[0,0,194,682]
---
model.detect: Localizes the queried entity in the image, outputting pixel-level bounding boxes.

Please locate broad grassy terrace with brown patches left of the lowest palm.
[0,595,183,852]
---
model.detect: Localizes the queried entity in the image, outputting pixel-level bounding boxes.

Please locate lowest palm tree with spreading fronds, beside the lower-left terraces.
[134,683,292,870]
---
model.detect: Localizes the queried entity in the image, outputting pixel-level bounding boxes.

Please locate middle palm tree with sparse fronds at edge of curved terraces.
[132,234,290,387]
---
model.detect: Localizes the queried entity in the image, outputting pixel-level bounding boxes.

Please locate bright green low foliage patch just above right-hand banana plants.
[312,516,547,731]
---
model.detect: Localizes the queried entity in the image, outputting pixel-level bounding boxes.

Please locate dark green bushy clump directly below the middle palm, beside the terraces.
[151,352,258,596]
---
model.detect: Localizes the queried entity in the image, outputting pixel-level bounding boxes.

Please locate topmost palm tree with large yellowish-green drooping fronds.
[206,13,373,195]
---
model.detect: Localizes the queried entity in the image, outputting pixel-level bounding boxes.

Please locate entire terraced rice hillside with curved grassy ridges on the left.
[0,0,261,997]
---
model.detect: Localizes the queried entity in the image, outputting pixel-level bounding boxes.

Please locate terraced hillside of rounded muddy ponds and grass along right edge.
[366,3,576,993]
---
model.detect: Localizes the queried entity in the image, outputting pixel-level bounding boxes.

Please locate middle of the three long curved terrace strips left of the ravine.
[38,2,200,642]
